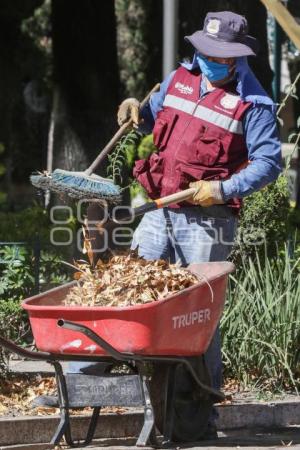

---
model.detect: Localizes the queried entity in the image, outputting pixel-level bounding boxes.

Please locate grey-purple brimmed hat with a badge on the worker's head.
[185,11,258,58]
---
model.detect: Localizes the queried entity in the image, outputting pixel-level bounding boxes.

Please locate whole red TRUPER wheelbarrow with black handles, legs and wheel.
[0,262,234,446]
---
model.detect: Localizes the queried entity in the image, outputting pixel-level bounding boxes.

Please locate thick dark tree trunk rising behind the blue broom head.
[52,0,119,173]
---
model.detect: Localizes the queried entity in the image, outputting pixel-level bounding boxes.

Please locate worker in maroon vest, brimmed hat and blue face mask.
[118,11,281,436]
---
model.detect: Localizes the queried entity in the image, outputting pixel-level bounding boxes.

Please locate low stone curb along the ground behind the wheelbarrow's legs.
[0,401,300,450]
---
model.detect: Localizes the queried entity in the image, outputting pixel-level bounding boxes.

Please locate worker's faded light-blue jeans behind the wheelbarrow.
[131,207,237,389]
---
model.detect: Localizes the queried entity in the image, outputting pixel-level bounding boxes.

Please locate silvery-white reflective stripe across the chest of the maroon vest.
[163,94,243,134]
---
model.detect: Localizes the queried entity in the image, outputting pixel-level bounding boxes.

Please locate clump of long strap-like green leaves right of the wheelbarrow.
[221,246,300,391]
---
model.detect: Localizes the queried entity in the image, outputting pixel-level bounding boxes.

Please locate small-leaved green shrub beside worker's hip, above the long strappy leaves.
[232,175,290,262]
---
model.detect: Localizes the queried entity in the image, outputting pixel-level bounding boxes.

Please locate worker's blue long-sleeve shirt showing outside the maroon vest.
[141,71,281,201]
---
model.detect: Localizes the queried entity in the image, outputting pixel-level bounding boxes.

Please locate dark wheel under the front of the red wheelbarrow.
[150,356,213,442]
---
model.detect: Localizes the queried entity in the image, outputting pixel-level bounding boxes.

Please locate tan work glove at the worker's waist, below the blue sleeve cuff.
[189,180,225,206]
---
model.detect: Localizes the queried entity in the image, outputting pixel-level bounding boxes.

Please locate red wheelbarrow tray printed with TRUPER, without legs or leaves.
[22,262,234,357]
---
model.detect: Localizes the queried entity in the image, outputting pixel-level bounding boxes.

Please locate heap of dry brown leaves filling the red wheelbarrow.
[65,253,199,307]
